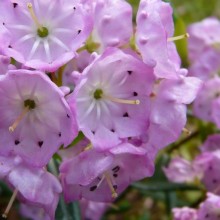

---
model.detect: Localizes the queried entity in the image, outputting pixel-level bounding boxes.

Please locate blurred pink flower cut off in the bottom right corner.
[197,193,220,220]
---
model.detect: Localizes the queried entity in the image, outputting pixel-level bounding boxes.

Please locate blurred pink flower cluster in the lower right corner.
[164,134,220,220]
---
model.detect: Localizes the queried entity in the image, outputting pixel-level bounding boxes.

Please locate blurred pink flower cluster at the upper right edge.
[188,18,220,127]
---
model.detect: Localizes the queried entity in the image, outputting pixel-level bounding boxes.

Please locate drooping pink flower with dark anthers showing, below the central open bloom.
[60,143,154,202]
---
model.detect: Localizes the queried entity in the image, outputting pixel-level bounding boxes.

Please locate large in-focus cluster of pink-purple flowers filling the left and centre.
[0,0,201,219]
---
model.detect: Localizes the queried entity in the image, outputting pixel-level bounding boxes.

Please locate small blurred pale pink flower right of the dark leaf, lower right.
[163,157,203,183]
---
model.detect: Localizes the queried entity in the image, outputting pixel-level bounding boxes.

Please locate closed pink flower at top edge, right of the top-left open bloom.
[93,0,133,50]
